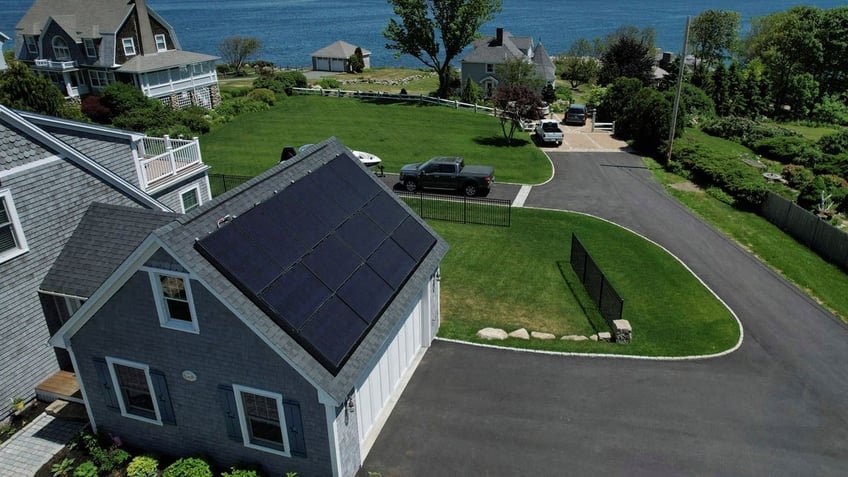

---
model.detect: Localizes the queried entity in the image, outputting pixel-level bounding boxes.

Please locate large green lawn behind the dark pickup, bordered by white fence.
[200,96,552,184]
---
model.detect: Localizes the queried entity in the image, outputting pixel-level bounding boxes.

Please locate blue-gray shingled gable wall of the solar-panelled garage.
[71,272,334,476]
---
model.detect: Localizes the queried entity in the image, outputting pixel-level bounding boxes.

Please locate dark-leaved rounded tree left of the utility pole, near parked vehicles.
[598,36,654,86]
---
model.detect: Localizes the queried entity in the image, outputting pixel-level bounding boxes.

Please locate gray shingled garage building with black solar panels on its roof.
[48,139,447,476]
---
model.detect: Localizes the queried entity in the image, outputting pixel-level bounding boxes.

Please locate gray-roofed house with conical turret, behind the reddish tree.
[461,28,556,96]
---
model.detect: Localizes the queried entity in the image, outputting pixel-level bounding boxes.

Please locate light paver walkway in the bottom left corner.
[0,413,88,477]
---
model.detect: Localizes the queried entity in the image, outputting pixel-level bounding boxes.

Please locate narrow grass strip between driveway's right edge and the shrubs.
[645,155,848,321]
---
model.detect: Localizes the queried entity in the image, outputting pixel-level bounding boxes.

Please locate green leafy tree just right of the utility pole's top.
[689,10,741,82]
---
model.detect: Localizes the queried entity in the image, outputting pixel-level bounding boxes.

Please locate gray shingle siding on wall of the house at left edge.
[0,160,134,410]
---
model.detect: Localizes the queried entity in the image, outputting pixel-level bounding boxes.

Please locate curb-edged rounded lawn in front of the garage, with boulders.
[430,209,739,356]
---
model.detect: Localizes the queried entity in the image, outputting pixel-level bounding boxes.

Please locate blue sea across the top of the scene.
[0,0,845,68]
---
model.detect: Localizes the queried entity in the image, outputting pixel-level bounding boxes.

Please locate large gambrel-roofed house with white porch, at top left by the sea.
[15,0,220,109]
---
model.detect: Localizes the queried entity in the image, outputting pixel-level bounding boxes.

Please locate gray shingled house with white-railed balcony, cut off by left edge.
[0,105,210,420]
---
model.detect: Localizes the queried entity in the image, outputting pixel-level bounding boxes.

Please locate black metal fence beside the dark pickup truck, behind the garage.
[395,191,512,227]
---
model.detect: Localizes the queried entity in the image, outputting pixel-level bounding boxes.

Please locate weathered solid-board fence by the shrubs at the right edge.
[762,192,848,270]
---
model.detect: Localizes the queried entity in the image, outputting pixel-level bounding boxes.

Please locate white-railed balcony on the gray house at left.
[138,136,205,193]
